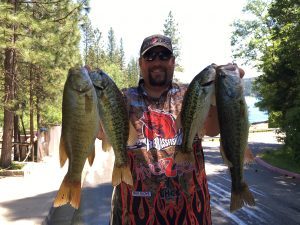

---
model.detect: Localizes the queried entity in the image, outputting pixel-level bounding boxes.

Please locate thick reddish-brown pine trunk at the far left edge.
[0,48,16,168]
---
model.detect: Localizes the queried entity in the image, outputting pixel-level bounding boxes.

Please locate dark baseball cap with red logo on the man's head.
[140,34,173,55]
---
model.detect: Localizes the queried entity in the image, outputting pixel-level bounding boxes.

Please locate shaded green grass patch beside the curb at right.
[260,148,300,174]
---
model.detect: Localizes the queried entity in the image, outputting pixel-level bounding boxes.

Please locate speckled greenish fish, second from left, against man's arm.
[90,70,133,186]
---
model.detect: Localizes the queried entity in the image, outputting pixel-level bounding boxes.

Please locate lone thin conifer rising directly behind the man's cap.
[163,11,183,71]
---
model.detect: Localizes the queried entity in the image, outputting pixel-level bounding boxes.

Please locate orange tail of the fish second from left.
[112,165,133,186]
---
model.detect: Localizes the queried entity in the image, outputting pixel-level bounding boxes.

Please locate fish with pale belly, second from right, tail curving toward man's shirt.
[175,64,216,163]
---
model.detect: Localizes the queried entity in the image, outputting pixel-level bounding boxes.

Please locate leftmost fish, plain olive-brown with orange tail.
[54,67,100,209]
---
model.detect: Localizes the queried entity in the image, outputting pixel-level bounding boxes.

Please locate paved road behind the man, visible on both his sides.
[50,134,300,225]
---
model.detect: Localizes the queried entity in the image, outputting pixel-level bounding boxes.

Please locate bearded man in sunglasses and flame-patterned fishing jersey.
[110,35,243,225]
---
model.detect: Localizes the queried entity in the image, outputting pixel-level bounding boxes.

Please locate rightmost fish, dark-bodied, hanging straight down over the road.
[215,65,255,212]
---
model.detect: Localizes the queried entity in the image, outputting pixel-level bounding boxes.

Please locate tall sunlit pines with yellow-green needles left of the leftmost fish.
[0,0,82,167]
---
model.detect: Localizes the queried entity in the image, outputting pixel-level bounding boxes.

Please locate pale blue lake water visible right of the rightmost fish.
[245,96,268,123]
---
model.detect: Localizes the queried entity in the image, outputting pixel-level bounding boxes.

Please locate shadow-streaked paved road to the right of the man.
[205,142,300,225]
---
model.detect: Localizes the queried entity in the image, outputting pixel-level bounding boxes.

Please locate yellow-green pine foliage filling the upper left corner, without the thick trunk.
[0,0,83,130]
